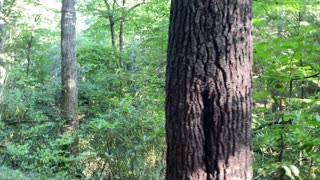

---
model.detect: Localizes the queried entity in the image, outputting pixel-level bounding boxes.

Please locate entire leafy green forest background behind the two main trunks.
[0,0,320,179]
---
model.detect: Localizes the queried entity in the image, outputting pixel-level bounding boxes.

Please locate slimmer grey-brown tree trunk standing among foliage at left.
[61,0,79,130]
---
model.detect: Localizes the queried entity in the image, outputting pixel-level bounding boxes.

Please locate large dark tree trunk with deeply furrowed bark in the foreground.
[166,0,252,180]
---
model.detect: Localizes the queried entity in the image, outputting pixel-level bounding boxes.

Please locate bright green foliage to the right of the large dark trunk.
[253,1,320,179]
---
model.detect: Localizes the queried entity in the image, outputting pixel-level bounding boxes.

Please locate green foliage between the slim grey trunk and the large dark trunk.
[78,1,167,176]
